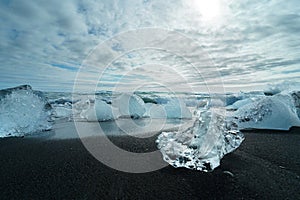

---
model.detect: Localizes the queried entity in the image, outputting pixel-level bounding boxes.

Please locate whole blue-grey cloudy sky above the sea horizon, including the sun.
[0,0,300,92]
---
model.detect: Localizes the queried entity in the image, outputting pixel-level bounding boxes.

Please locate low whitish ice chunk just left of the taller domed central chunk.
[80,100,118,121]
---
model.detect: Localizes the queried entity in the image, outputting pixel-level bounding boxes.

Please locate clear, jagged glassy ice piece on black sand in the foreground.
[156,108,244,172]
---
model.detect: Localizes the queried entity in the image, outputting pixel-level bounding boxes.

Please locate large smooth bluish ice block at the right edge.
[233,94,300,130]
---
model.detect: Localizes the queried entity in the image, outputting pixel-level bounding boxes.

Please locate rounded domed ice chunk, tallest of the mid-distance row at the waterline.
[112,93,146,118]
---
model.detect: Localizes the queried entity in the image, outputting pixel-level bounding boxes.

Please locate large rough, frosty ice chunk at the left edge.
[0,86,52,137]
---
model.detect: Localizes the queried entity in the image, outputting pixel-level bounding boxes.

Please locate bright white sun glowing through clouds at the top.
[193,0,221,21]
